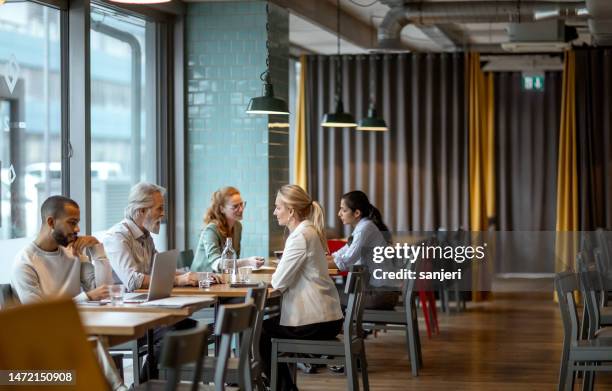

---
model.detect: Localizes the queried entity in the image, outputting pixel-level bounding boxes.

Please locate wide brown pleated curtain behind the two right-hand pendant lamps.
[306,54,469,236]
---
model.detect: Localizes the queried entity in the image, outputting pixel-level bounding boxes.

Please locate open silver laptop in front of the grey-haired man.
[123,250,179,303]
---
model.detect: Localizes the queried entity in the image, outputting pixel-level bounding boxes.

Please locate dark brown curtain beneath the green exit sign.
[495,72,562,273]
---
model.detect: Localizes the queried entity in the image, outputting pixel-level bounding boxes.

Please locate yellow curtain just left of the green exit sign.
[467,53,495,301]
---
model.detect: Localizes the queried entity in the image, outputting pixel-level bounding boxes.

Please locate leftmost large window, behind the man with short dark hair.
[0,2,62,239]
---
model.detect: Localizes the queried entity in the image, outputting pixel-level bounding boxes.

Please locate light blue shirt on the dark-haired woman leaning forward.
[332,217,388,270]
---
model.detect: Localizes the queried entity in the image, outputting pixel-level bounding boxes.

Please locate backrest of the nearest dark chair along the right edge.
[555,272,579,341]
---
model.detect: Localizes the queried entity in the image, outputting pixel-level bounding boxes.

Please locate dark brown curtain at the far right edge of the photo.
[575,49,612,231]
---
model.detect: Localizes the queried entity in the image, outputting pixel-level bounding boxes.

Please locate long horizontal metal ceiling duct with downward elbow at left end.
[378,0,588,49]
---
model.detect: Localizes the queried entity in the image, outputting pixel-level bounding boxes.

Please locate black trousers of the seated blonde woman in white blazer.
[259,316,344,391]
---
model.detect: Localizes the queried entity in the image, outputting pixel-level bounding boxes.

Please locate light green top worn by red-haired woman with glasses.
[191,221,242,273]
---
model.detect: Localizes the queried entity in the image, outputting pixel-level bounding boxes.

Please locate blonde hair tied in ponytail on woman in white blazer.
[278,185,328,250]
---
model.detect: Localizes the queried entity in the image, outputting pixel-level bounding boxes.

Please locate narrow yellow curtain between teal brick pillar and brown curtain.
[293,56,308,191]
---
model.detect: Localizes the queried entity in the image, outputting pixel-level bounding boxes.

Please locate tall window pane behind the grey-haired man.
[91,6,157,232]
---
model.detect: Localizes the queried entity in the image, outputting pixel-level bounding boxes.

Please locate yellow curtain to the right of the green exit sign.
[555,51,579,272]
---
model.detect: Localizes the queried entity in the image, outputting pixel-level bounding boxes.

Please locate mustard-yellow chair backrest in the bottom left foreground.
[0,299,109,390]
